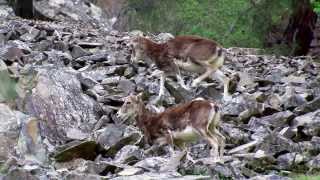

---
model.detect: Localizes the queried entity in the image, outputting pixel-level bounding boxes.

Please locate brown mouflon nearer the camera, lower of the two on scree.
[117,95,225,160]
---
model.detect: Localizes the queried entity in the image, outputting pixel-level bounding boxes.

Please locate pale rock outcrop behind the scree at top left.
[6,0,115,30]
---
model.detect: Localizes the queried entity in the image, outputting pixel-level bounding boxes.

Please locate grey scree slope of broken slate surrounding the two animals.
[0,6,320,179]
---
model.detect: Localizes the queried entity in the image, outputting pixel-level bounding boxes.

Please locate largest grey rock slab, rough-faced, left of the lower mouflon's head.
[24,67,100,144]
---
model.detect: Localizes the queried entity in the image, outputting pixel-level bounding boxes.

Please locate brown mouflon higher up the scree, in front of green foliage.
[132,36,231,100]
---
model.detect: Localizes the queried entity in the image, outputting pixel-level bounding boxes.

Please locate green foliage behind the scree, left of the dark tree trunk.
[129,0,292,51]
